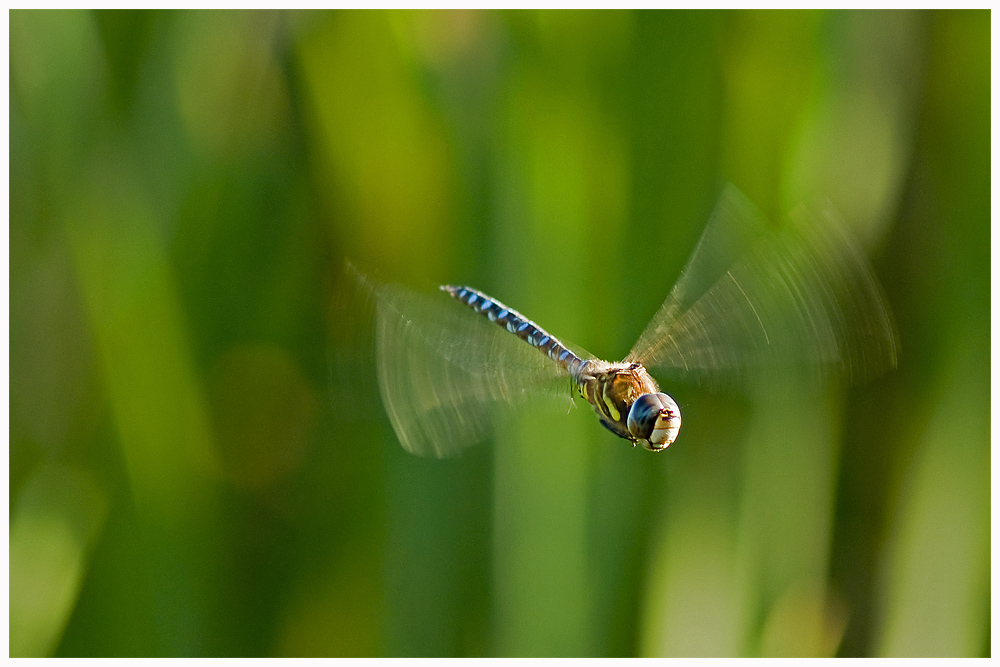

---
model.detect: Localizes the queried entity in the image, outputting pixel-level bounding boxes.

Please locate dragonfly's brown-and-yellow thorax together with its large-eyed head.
[574,360,681,451]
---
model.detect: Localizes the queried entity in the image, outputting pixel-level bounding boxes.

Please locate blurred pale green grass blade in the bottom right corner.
[878,348,990,657]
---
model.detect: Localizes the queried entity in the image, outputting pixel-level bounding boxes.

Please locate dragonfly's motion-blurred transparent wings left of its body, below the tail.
[358,268,572,458]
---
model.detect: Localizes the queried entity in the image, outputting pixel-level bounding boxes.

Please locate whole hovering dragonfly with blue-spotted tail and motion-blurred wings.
[356,185,899,458]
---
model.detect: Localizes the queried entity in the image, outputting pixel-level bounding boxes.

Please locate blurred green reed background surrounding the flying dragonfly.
[9,11,990,656]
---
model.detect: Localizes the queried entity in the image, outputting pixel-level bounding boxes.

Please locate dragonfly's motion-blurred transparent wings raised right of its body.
[627,185,898,389]
